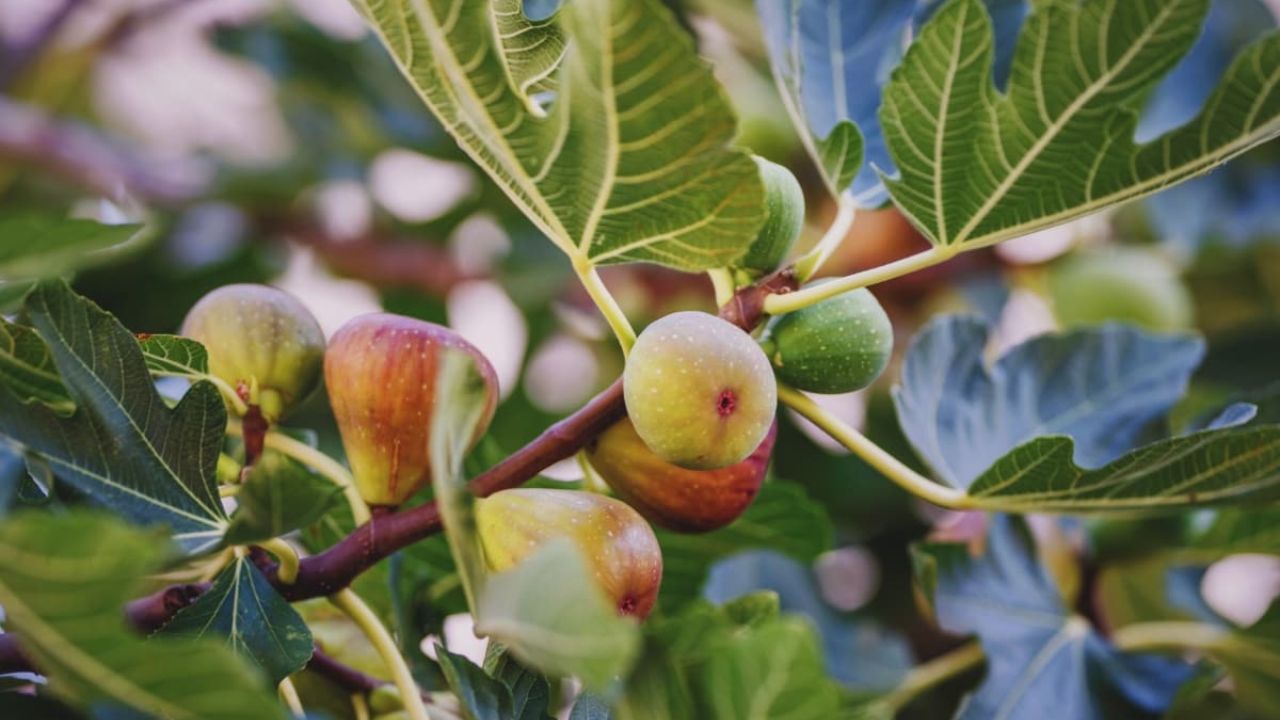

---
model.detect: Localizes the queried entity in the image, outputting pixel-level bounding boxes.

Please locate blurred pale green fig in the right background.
[1048,247,1194,331]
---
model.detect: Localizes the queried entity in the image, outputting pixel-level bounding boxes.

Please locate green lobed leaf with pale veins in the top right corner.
[881,0,1280,247]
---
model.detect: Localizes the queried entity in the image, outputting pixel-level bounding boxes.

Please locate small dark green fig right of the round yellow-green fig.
[762,283,893,393]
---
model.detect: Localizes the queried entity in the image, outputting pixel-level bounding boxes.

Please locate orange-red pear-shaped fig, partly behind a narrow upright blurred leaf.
[324,313,498,505]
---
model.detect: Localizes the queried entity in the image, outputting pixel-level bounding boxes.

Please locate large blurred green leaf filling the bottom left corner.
[0,511,284,720]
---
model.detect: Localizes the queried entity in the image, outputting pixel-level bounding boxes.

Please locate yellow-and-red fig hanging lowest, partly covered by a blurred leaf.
[475,488,662,618]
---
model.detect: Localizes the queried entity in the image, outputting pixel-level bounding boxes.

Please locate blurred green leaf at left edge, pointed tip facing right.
[0,213,142,279]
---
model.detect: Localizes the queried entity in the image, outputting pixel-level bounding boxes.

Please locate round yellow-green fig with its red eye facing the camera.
[622,311,778,470]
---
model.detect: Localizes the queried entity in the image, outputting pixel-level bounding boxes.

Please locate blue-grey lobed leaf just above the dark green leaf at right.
[893,315,1204,488]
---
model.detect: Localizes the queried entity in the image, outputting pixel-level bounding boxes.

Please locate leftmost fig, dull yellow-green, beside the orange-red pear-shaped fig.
[182,284,324,423]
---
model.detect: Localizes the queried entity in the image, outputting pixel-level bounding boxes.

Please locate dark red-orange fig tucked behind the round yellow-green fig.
[586,419,778,533]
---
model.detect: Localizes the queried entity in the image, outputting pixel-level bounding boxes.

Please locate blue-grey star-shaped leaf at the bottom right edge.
[913,515,1189,720]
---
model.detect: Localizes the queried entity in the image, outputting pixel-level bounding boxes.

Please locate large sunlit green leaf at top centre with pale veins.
[353,0,764,270]
